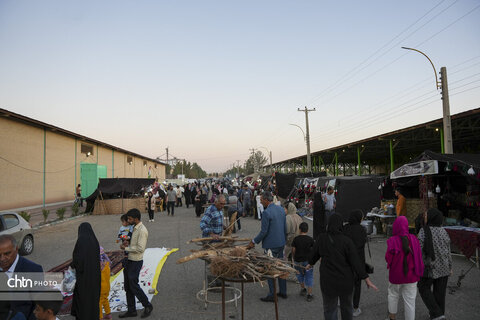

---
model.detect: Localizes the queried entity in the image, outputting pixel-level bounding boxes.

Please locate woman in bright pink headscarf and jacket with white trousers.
[385,216,424,320]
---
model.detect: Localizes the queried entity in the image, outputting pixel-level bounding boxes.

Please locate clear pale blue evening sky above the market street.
[0,0,480,172]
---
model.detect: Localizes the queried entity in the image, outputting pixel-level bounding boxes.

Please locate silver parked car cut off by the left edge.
[0,211,33,256]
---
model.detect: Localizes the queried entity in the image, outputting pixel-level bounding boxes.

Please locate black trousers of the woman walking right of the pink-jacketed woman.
[417,276,448,319]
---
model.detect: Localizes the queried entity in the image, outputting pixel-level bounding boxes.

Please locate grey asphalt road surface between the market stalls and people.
[27,207,480,320]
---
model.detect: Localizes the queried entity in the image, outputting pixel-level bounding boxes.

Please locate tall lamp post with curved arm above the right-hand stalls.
[402,47,453,154]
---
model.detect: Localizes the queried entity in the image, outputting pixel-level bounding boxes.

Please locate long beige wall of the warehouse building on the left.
[0,117,165,210]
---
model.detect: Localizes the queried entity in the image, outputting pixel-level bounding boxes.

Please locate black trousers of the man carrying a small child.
[123,260,150,312]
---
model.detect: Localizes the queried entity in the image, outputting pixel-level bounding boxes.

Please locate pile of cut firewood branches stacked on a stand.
[177,237,296,282]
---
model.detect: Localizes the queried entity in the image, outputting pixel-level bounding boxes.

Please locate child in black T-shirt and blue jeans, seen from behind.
[292,222,313,302]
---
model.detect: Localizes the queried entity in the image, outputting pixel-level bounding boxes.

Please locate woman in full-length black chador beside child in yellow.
[71,222,100,320]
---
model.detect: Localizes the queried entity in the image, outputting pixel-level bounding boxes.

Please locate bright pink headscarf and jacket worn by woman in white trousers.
[385,216,424,284]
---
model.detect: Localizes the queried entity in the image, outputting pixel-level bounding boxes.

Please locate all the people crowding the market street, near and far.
[0,178,452,320]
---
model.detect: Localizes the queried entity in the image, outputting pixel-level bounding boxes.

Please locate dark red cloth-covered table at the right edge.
[443,226,480,268]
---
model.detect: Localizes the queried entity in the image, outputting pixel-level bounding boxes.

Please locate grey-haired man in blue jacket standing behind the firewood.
[248,191,287,302]
